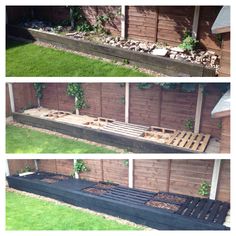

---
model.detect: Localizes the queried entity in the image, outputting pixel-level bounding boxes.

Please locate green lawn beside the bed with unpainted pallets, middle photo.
[6,125,118,153]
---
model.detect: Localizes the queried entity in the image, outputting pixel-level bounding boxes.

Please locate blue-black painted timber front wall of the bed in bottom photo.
[7,173,229,230]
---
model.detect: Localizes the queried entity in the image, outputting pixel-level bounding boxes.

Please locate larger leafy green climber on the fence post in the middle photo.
[67,83,87,110]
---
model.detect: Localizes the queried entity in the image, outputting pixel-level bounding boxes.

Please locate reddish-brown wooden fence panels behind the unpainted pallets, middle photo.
[6,83,222,138]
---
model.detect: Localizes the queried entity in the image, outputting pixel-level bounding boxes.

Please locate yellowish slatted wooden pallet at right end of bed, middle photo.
[166,130,211,152]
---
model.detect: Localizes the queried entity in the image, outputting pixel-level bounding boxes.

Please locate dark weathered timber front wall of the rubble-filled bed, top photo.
[6,25,216,77]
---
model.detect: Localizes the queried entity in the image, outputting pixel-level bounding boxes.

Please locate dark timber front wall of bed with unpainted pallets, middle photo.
[12,112,194,153]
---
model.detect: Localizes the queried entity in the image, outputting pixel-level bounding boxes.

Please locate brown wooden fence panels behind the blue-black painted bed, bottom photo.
[8,159,230,201]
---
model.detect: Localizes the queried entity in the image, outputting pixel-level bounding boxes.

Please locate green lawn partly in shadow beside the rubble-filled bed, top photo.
[6,41,148,77]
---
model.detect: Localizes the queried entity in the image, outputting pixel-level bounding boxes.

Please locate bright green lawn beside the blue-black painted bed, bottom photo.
[6,192,142,230]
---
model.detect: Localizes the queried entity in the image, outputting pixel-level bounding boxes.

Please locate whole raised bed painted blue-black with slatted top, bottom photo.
[7,172,230,230]
